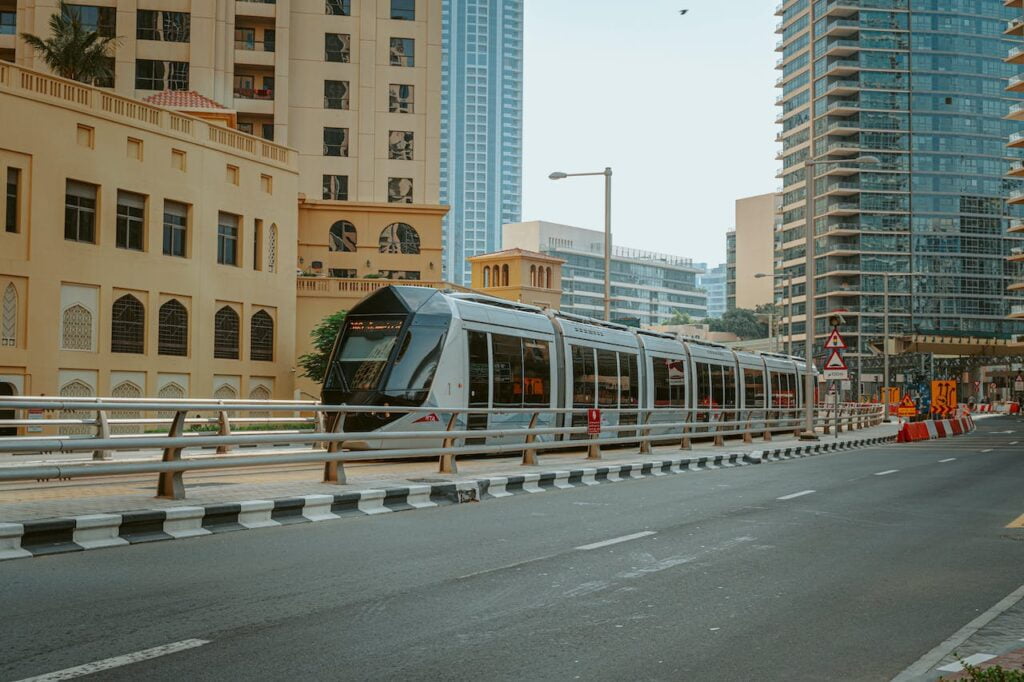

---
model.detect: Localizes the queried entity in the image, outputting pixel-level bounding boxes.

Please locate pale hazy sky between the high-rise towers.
[522,0,781,264]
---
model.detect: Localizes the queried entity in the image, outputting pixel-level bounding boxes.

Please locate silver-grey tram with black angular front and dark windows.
[323,286,813,450]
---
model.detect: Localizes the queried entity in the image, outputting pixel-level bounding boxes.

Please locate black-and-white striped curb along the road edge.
[0,436,895,561]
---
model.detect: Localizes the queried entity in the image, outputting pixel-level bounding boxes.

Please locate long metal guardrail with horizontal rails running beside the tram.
[0,397,883,500]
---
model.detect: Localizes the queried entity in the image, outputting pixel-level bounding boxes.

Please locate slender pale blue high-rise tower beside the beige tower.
[440,0,522,285]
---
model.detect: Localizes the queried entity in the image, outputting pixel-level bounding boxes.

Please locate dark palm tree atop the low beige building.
[22,0,118,84]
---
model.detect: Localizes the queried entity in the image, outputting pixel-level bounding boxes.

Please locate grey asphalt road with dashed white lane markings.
[0,418,1024,680]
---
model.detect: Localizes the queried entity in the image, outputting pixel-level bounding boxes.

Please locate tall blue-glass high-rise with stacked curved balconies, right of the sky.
[775,0,1024,366]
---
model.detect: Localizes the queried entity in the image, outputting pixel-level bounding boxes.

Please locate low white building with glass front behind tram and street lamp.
[502,220,708,327]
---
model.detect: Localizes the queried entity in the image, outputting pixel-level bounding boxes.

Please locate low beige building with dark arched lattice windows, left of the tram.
[0,62,298,405]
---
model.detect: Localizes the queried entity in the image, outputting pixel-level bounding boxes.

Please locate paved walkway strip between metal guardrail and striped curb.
[0,423,898,522]
